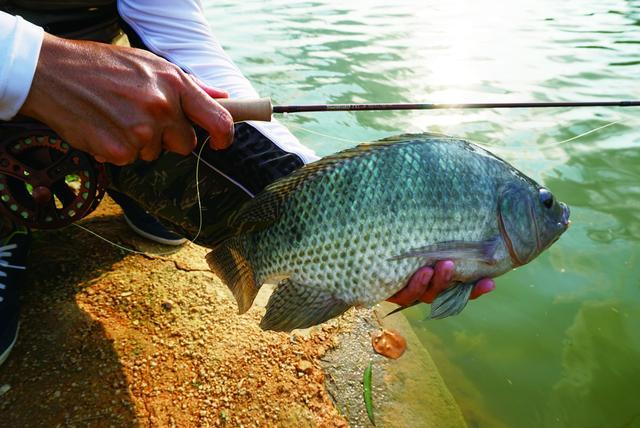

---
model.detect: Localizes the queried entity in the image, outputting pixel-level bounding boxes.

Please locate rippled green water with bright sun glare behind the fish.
[205,0,640,427]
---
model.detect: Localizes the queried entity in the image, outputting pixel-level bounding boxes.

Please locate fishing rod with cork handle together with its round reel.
[0,96,640,229]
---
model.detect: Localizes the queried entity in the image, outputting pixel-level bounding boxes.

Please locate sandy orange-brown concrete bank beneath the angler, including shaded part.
[0,199,463,427]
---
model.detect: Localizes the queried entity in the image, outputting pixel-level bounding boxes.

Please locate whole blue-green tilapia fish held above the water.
[207,134,569,331]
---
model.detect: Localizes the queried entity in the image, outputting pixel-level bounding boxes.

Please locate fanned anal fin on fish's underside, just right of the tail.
[260,279,351,332]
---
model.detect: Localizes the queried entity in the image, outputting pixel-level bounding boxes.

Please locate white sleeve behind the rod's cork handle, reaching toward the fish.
[118,0,317,163]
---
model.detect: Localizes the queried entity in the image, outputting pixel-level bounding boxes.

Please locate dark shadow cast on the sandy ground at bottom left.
[0,216,136,427]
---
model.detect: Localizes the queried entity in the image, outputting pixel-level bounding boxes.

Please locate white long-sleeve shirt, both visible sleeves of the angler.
[0,0,317,163]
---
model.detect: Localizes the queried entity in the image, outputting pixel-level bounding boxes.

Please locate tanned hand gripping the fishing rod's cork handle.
[20,34,233,165]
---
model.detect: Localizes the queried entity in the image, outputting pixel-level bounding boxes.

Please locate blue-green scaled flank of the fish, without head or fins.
[248,140,497,305]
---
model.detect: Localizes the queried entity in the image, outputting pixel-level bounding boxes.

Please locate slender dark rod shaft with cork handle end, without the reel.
[217,98,640,122]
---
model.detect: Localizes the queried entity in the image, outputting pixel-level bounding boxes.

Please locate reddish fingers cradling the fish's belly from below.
[387,260,496,306]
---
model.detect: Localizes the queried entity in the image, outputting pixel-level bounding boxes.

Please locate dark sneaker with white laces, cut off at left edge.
[0,220,31,365]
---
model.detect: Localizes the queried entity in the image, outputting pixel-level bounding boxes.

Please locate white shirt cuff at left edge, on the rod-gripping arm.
[0,12,44,120]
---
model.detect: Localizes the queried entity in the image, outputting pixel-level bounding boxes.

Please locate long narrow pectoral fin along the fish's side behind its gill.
[389,235,501,264]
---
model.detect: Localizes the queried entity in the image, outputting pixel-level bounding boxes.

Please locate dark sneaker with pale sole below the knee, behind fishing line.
[109,190,187,245]
